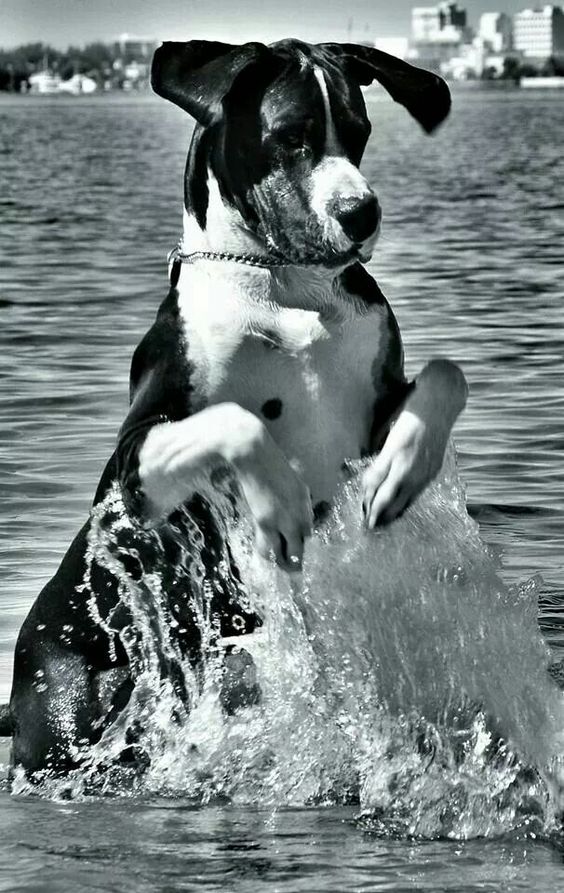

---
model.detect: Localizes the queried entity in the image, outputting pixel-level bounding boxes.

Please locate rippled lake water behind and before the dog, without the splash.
[0,85,564,893]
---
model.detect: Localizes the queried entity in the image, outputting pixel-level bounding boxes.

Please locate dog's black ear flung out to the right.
[321,43,450,133]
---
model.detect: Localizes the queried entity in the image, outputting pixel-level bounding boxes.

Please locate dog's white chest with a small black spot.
[181,290,380,501]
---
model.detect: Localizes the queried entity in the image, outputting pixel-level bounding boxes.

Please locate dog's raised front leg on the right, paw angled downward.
[362,360,468,529]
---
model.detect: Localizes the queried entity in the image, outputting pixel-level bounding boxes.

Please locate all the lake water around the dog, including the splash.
[0,91,564,893]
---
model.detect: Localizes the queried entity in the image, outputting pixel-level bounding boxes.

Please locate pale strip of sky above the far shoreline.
[0,0,538,49]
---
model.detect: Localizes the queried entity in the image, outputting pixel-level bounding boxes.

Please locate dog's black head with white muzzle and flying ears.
[152,40,450,266]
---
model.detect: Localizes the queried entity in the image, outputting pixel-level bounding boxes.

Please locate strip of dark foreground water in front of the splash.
[4,800,563,893]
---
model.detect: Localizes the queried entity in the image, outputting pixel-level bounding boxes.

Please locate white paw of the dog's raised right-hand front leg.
[361,410,449,530]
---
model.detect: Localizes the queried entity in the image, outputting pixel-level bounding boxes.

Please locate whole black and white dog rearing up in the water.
[10,40,466,773]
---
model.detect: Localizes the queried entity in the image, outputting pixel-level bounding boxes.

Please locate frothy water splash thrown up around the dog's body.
[15,454,564,838]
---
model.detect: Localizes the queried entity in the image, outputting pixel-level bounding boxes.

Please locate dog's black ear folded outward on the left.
[151,40,268,125]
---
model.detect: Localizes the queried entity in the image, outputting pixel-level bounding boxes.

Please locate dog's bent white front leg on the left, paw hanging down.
[139,403,312,570]
